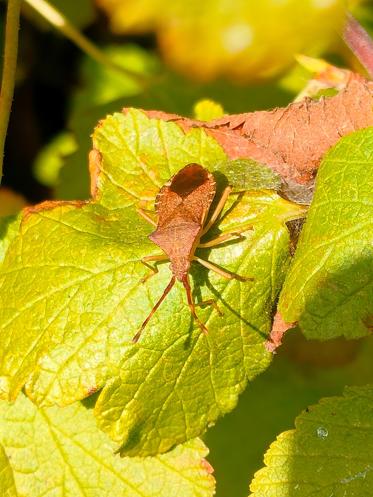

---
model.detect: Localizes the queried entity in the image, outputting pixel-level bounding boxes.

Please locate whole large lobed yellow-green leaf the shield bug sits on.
[0,110,301,454]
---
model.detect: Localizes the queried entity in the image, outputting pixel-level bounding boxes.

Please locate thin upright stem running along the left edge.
[0,0,22,183]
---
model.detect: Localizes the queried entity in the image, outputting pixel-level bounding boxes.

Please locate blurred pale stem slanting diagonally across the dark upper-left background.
[25,0,148,86]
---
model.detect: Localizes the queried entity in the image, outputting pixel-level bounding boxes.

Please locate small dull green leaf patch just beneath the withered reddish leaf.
[219,159,282,191]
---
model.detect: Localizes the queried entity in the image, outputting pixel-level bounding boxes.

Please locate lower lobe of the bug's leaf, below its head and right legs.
[96,184,300,454]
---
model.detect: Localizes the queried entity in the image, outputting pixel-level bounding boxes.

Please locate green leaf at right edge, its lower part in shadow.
[279,128,373,339]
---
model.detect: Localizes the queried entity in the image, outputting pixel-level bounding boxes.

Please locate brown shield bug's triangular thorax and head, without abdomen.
[149,216,202,280]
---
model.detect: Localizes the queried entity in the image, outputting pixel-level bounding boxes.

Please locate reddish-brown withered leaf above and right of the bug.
[136,73,373,198]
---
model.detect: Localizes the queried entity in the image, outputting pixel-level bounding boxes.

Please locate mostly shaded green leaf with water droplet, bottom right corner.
[250,386,373,497]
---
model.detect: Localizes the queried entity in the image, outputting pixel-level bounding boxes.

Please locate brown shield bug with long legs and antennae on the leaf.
[132,164,252,342]
